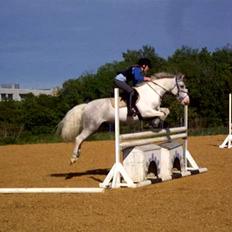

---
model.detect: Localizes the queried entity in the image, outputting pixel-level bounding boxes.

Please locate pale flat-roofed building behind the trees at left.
[0,84,57,101]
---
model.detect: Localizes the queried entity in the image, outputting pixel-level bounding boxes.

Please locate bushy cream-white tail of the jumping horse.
[56,104,87,141]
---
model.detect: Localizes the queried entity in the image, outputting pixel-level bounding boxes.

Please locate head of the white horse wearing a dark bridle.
[171,74,190,105]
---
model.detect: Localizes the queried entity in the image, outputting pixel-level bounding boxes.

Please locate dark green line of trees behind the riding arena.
[0,45,232,143]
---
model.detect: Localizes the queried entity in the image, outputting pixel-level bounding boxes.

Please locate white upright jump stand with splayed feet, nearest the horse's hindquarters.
[100,88,136,188]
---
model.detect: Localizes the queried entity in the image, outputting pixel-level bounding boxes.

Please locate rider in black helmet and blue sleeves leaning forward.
[115,58,151,117]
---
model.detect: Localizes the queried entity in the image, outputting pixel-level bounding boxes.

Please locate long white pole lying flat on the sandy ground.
[0,188,104,193]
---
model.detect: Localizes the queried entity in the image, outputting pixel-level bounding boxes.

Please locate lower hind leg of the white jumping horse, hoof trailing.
[70,129,93,164]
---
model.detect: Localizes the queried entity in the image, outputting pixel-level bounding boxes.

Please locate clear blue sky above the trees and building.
[0,0,232,88]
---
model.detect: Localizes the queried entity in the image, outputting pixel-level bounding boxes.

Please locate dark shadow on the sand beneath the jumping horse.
[49,168,110,182]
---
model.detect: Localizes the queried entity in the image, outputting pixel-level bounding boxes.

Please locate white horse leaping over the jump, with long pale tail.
[57,73,189,164]
